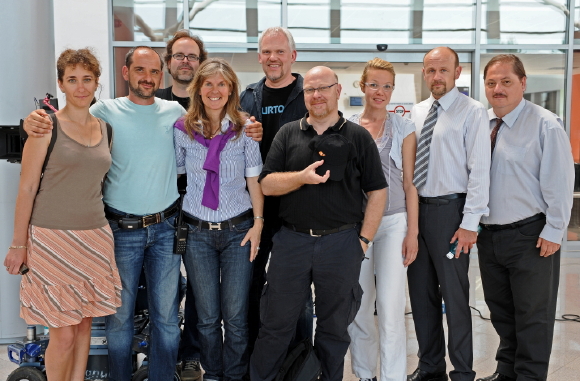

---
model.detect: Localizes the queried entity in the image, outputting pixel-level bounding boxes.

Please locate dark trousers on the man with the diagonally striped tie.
[407,199,475,381]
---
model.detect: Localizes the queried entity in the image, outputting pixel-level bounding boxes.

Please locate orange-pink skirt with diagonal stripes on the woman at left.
[20,225,122,328]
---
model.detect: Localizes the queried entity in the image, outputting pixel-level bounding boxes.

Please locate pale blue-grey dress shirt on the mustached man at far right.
[482,99,574,243]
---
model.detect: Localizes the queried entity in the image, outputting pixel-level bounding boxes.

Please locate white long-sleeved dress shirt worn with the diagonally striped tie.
[411,87,491,231]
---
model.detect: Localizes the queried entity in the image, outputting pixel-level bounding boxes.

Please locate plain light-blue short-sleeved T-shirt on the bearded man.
[90,97,185,216]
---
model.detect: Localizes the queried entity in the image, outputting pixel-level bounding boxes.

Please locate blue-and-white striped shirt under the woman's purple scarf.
[174,115,262,222]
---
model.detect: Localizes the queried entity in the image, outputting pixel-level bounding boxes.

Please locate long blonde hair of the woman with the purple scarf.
[184,58,246,139]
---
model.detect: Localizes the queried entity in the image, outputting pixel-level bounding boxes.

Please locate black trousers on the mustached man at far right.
[477,219,560,381]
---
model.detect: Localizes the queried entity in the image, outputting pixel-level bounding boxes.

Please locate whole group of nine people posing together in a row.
[4,27,574,381]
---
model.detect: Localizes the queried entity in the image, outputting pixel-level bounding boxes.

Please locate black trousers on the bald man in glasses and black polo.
[250,227,364,381]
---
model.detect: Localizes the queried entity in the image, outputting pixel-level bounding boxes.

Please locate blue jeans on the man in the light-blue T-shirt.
[106,207,181,381]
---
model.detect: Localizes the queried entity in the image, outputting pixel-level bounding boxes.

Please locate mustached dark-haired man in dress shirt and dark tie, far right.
[477,54,574,381]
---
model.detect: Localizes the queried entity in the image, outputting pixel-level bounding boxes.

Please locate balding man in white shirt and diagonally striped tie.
[407,47,490,381]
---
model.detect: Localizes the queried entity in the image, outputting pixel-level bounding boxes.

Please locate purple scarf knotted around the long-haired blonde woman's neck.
[174,119,235,210]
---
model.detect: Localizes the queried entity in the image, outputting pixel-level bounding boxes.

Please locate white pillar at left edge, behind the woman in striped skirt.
[0,0,56,343]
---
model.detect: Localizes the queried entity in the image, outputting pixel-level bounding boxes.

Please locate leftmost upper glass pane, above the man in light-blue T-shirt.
[113,0,183,41]
